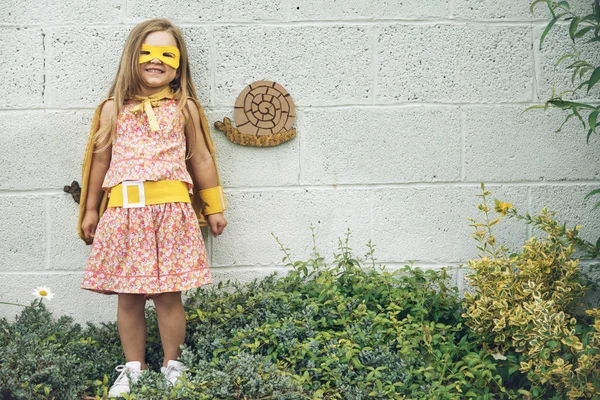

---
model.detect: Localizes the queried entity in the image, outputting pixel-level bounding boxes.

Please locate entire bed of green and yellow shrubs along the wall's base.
[0,187,600,400]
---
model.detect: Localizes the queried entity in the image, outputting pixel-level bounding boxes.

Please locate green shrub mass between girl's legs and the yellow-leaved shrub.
[148,233,505,399]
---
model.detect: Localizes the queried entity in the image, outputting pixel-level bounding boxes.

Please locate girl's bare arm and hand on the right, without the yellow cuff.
[185,100,227,236]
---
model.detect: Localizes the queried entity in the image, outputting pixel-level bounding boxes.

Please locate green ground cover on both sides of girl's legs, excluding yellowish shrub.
[0,231,512,400]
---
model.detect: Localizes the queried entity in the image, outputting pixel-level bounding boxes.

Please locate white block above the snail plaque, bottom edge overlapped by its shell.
[214,23,373,106]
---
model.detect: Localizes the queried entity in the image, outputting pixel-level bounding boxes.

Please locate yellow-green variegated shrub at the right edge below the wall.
[464,185,600,399]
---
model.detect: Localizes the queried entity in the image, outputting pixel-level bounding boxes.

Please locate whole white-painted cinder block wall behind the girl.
[0,0,600,321]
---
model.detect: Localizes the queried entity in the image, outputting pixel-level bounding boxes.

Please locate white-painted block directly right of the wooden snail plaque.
[298,106,461,185]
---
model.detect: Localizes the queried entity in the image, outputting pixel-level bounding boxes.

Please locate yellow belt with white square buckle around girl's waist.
[108,181,191,208]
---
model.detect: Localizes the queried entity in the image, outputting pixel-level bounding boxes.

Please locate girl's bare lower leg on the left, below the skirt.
[117,293,146,369]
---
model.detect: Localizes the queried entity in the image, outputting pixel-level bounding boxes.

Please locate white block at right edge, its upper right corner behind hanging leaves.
[463,105,600,182]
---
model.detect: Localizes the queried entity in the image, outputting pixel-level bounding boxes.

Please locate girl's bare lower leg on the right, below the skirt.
[152,292,185,367]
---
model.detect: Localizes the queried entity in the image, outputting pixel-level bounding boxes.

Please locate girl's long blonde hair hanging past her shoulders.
[94,19,198,153]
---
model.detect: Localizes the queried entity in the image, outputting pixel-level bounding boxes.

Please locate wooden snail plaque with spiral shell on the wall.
[215,81,296,147]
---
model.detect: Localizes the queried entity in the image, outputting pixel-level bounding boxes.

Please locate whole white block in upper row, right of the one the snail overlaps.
[376,24,533,103]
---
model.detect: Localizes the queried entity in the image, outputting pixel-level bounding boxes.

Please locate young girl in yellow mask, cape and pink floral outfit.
[79,19,227,397]
